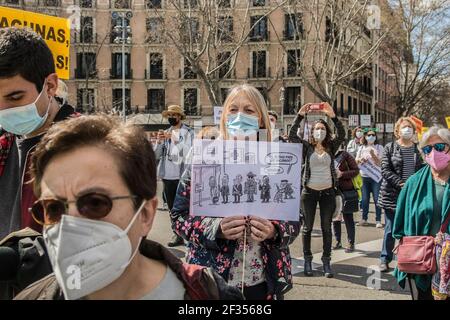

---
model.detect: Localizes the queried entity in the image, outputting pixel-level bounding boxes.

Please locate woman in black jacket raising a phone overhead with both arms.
[289,103,345,278]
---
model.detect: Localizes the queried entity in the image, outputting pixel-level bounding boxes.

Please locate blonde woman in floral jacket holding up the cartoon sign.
[171,84,299,300]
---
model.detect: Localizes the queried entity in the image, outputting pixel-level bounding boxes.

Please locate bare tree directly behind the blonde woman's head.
[151,0,288,109]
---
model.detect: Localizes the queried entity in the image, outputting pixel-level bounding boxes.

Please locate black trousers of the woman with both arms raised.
[301,187,336,258]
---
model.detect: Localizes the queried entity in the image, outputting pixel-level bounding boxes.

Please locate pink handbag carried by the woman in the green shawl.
[394,214,450,274]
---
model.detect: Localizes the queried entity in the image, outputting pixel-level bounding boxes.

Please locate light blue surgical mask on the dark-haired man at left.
[0,83,53,136]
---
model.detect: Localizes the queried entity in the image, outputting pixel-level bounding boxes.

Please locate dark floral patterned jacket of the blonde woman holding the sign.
[170,168,300,300]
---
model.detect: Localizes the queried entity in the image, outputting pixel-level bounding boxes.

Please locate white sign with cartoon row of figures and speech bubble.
[190,139,302,221]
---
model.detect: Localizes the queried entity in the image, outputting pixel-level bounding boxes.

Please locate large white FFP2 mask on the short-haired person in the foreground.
[43,201,145,300]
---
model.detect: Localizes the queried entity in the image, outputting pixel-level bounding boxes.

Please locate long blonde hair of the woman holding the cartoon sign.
[220,84,272,141]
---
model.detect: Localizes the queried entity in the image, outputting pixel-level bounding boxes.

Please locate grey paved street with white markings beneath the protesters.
[149,184,410,300]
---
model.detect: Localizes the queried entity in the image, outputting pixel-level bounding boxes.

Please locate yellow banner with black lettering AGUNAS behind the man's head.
[0,7,70,79]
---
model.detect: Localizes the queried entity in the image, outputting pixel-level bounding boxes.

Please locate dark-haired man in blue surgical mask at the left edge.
[0,28,75,299]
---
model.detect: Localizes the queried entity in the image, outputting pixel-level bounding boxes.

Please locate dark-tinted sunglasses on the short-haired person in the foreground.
[29,193,137,225]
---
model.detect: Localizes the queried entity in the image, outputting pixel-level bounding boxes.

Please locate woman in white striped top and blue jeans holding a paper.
[356,129,384,228]
